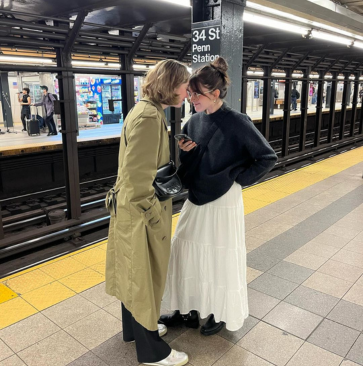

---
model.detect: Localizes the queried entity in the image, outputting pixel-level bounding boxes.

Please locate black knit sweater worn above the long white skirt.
[180,103,277,206]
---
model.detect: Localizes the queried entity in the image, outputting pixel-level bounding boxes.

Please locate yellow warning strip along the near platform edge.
[0,147,363,329]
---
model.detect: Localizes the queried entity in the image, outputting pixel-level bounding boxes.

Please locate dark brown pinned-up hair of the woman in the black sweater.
[189,57,231,99]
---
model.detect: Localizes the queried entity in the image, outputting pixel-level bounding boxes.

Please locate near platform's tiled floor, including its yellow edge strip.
[0,149,363,366]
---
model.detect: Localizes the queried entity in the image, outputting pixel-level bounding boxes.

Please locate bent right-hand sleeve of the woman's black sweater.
[236,116,277,186]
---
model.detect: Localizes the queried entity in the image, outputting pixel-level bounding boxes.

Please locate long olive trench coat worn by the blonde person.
[106,98,172,331]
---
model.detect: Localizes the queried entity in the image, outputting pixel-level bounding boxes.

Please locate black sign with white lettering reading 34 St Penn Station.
[192,20,221,70]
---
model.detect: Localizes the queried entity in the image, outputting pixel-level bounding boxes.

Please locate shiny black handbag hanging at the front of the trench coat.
[153,160,183,202]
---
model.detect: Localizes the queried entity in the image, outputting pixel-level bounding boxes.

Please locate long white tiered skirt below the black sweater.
[163,183,248,331]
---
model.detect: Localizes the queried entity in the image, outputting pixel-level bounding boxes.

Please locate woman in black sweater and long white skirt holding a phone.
[160,57,277,335]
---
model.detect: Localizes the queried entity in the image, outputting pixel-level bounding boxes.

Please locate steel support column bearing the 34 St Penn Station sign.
[192,0,246,111]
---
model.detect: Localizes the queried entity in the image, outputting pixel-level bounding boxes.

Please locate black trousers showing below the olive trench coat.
[121,304,171,362]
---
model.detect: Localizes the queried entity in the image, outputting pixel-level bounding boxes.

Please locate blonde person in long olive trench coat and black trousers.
[106,60,189,365]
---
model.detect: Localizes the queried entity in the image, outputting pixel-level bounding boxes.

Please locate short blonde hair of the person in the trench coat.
[142,60,190,105]
